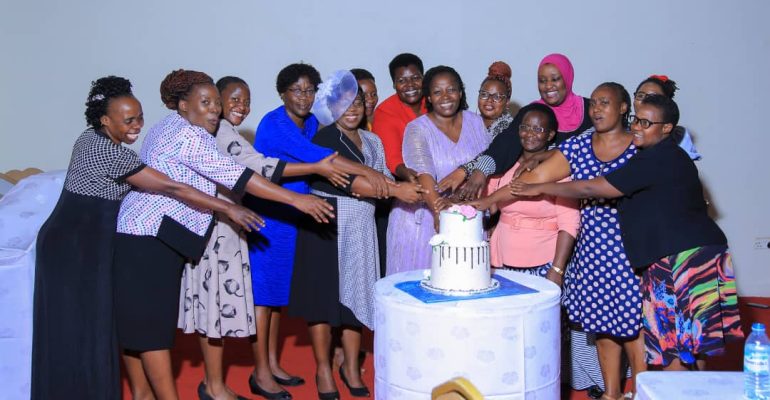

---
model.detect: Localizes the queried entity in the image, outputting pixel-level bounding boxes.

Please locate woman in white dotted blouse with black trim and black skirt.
[115,70,334,400]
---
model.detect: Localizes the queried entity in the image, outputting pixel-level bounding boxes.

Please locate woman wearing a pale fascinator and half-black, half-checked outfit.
[289,71,421,400]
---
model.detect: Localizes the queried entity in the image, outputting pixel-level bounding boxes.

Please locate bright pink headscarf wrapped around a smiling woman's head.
[534,53,584,132]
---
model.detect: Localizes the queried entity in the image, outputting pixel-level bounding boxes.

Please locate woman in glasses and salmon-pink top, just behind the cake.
[479,103,580,286]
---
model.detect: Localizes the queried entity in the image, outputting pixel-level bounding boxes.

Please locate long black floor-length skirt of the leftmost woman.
[30,190,121,399]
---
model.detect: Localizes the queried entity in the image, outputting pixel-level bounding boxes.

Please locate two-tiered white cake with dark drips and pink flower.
[427,205,492,294]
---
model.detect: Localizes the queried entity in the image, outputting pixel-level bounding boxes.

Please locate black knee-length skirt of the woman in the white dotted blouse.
[115,233,185,352]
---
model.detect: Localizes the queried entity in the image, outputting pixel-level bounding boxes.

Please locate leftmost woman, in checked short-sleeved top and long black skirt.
[31,76,261,400]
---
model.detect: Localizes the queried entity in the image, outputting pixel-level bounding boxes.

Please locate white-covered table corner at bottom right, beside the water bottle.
[636,371,743,400]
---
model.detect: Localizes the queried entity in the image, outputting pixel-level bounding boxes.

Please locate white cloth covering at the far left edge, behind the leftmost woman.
[0,171,66,399]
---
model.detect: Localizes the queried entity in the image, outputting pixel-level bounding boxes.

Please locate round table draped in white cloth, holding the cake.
[374,271,561,400]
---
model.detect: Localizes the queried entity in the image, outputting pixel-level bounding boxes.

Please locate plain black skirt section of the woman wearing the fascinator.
[288,198,363,328]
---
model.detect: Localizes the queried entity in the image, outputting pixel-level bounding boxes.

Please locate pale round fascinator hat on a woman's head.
[312,70,358,125]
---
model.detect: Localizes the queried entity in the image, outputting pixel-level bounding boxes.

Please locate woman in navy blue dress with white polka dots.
[504,82,646,399]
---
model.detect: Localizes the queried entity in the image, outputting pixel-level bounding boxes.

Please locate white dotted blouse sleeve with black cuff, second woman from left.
[178,127,254,193]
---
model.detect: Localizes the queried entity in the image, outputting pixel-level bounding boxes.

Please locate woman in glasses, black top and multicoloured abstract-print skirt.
[514,95,743,370]
